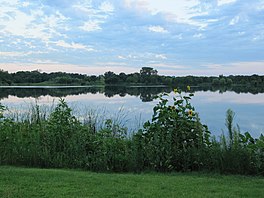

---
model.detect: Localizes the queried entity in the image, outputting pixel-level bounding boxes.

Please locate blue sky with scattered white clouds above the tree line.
[0,0,264,76]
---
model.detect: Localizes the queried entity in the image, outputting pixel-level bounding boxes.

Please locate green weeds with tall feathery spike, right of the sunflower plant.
[208,109,264,175]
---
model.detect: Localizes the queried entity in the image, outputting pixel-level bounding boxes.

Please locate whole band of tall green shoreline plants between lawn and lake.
[0,86,264,176]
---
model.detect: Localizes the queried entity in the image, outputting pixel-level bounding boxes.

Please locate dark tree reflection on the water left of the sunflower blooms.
[0,86,172,102]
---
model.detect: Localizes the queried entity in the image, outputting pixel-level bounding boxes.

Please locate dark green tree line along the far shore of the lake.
[0,67,264,87]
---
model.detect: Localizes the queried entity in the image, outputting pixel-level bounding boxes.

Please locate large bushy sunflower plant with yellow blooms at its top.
[137,86,210,171]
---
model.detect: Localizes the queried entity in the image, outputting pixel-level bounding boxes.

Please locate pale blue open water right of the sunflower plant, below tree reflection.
[192,91,264,137]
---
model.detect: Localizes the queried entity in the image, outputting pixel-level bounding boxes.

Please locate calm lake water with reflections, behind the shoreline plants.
[0,86,264,137]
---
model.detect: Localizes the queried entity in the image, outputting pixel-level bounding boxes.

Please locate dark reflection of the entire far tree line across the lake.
[0,86,264,102]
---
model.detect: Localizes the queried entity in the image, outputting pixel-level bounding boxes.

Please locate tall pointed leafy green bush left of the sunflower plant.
[41,99,81,167]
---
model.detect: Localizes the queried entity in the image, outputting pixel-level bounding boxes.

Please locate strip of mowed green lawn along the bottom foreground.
[0,166,264,198]
